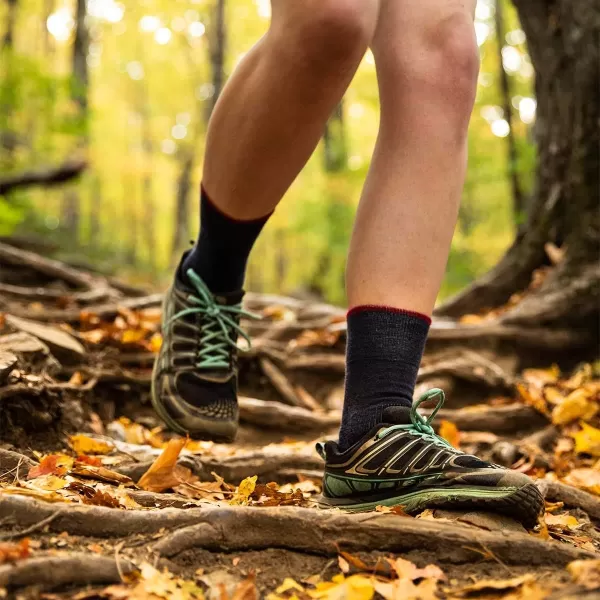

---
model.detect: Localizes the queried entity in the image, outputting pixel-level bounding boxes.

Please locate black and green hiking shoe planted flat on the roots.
[317,389,544,528]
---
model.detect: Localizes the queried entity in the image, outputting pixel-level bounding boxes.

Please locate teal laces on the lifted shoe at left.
[168,269,260,369]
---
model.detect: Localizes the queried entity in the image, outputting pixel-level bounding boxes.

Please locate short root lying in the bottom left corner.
[0,552,135,589]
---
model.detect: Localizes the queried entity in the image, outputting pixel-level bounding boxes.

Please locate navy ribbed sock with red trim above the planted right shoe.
[339,306,431,451]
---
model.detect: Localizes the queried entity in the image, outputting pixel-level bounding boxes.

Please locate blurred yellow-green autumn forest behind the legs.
[0,0,536,304]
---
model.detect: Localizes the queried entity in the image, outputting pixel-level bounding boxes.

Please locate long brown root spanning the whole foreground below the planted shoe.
[0,496,596,568]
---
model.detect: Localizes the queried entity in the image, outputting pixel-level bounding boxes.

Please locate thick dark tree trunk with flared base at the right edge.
[436,0,600,342]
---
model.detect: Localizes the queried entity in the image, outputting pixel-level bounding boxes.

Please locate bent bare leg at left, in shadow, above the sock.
[203,0,380,220]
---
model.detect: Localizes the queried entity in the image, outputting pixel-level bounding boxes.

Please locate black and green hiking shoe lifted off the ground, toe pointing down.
[152,269,254,442]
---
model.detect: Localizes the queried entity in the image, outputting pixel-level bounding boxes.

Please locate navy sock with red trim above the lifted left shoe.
[181,188,272,294]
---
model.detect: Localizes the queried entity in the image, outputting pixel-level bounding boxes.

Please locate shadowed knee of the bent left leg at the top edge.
[272,0,379,66]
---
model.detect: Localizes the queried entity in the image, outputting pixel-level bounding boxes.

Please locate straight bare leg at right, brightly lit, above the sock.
[347,0,479,315]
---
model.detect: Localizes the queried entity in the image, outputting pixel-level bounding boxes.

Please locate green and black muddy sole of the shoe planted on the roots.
[318,483,544,529]
